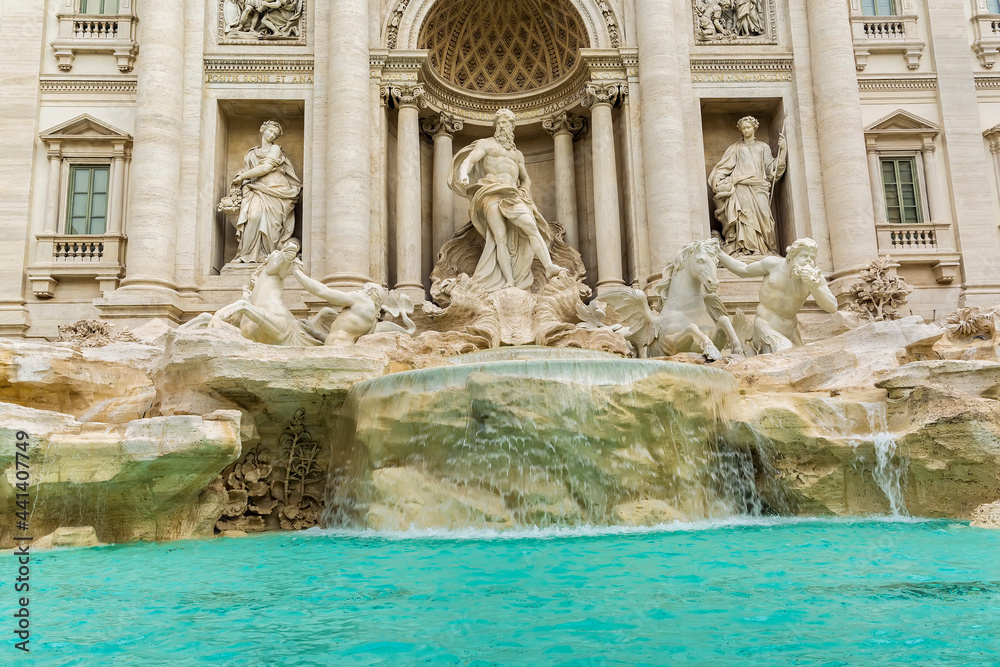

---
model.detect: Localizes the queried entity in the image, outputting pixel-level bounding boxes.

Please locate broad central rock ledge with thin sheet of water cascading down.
[326,348,784,529]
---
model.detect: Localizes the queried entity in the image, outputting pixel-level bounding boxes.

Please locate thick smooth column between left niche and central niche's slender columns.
[326,0,373,288]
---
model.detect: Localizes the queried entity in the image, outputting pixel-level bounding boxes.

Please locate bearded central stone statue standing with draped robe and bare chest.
[448,109,566,292]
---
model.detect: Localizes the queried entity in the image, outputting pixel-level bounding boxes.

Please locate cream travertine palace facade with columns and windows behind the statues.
[0,0,1000,338]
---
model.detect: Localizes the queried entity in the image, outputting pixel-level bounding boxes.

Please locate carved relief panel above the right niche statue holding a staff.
[691,0,777,44]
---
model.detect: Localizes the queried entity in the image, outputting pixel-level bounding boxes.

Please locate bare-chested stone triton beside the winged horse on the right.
[719,239,837,354]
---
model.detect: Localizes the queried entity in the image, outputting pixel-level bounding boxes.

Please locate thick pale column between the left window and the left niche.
[121,2,184,292]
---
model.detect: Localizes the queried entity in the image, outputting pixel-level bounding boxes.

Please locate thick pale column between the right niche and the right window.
[806,2,878,278]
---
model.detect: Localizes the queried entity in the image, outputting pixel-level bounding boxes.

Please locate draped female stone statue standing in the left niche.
[224,120,302,264]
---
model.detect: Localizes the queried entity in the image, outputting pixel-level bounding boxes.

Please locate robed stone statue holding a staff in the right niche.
[708,116,787,255]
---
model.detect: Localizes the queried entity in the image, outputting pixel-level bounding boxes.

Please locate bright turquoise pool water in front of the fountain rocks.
[7,519,1000,666]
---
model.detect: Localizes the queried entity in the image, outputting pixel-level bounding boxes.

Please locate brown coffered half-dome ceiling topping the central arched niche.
[417,0,590,95]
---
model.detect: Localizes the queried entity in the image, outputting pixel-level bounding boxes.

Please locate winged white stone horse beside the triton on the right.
[601,239,743,360]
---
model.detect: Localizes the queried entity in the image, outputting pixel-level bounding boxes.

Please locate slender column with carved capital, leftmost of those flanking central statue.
[390,85,424,303]
